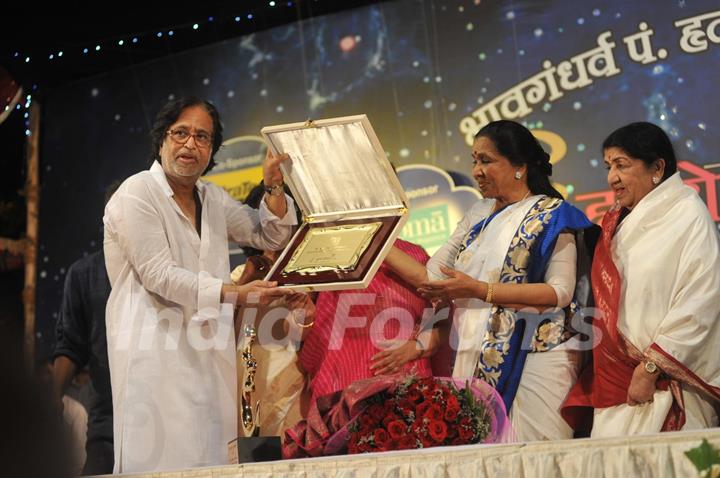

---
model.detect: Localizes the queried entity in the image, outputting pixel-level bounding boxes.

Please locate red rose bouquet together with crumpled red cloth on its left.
[282,375,513,458]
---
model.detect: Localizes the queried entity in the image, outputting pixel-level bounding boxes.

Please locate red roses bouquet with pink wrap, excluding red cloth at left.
[347,376,508,453]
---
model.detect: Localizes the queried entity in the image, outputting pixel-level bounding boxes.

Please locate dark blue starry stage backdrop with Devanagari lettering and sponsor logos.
[37,0,720,353]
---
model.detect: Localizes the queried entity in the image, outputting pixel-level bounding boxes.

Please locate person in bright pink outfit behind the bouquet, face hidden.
[300,239,439,406]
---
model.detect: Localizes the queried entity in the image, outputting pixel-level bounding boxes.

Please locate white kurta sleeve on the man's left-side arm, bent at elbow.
[106,181,207,309]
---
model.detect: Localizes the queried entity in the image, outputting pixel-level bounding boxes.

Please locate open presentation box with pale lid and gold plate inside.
[261,115,408,292]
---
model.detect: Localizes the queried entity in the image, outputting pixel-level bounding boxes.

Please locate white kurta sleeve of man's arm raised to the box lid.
[222,191,297,251]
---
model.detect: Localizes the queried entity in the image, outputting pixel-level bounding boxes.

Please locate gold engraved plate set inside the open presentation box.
[282,222,382,275]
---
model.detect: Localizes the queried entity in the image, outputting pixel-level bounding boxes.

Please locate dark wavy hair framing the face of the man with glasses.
[150,96,223,175]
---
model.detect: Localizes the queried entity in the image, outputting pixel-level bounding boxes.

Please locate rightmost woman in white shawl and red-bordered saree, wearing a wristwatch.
[563,123,720,437]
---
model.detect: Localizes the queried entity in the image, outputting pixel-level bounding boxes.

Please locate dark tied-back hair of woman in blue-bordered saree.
[475,120,563,199]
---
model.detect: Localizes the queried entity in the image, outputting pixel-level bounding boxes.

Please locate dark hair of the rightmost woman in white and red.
[602,121,677,181]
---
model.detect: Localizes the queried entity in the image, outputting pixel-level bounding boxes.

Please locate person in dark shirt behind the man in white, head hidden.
[53,251,113,475]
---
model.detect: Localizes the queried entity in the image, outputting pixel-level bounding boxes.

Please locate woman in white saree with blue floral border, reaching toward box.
[386,120,592,441]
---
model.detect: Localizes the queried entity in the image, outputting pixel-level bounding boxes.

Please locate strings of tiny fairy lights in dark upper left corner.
[5,0,298,136]
